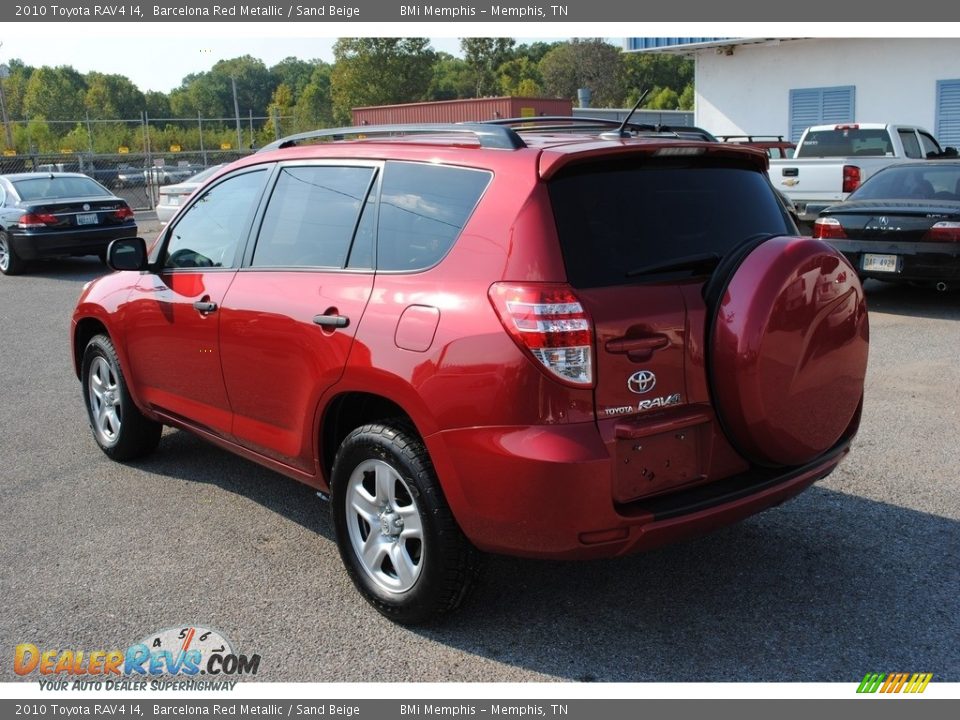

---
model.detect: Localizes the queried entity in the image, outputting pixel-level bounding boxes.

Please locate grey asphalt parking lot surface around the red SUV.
[0,223,960,682]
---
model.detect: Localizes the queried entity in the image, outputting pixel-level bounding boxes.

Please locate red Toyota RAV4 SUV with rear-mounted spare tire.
[72,120,868,623]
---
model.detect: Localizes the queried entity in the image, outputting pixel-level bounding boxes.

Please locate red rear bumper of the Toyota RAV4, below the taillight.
[426,424,849,559]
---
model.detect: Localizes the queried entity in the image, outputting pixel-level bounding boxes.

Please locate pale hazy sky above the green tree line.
[0,33,563,92]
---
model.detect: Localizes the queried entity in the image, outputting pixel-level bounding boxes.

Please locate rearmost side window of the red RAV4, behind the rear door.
[377,162,492,272]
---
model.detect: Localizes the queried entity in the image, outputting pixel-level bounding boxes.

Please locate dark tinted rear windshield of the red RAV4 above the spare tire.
[550,160,792,288]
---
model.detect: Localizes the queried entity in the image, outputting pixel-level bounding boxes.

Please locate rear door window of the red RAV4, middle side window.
[251,165,375,268]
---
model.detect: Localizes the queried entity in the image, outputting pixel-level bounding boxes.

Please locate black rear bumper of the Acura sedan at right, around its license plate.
[826,240,960,281]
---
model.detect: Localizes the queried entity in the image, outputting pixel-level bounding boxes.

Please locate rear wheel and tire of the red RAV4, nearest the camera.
[331,423,479,625]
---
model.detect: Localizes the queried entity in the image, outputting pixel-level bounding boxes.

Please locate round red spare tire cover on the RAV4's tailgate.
[709,237,869,465]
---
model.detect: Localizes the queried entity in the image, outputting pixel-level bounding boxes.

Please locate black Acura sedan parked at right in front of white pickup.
[813,160,960,290]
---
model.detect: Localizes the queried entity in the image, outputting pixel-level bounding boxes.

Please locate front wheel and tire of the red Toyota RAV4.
[80,335,163,461]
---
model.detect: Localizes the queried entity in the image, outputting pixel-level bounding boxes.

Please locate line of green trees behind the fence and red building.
[0,38,693,153]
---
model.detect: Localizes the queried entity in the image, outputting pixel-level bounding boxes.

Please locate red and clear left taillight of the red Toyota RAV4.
[489,283,593,387]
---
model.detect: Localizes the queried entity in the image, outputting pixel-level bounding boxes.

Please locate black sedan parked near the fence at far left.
[0,172,137,275]
